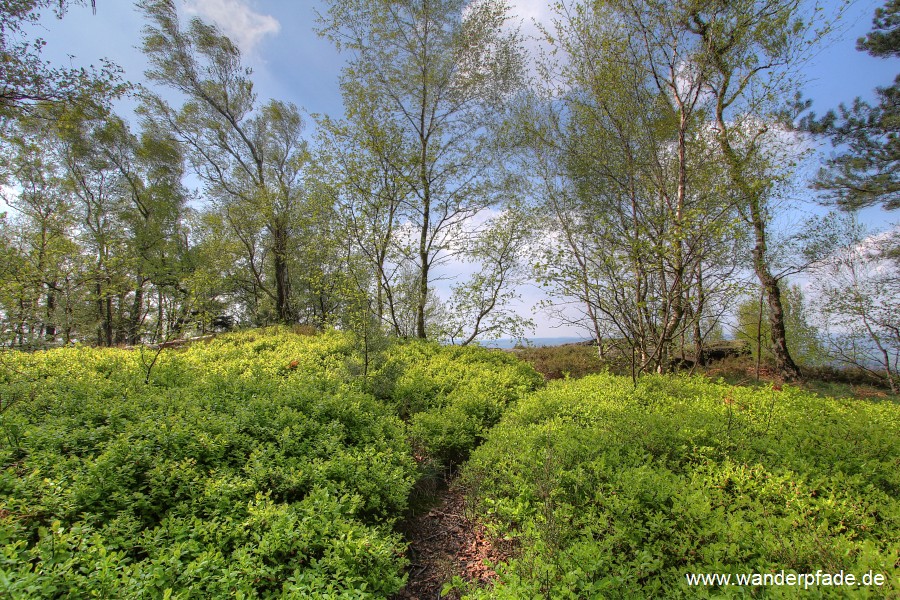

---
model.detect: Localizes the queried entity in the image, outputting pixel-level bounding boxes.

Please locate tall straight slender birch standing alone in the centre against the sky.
[320,0,523,338]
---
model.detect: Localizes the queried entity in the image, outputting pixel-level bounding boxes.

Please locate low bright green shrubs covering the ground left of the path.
[0,329,539,598]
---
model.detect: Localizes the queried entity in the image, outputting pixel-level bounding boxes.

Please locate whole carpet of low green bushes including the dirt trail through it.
[0,329,900,599]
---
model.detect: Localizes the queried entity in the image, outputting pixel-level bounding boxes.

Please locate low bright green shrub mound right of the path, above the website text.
[461,375,900,598]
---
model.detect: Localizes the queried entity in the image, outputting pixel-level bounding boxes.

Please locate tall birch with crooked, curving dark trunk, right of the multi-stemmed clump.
[674,0,817,380]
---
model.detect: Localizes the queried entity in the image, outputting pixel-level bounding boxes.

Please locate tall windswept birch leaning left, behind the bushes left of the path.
[138,0,332,325]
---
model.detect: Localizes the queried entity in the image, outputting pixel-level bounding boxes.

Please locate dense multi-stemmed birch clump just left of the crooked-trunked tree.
[523,1,734,372]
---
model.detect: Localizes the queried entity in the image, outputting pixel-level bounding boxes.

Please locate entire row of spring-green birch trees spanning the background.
[0,0,900,392]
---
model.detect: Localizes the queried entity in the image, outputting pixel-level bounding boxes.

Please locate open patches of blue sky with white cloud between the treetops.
[28,0,897,336]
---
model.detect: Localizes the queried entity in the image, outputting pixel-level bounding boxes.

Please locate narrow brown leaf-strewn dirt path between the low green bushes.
[394,484,507,600]
